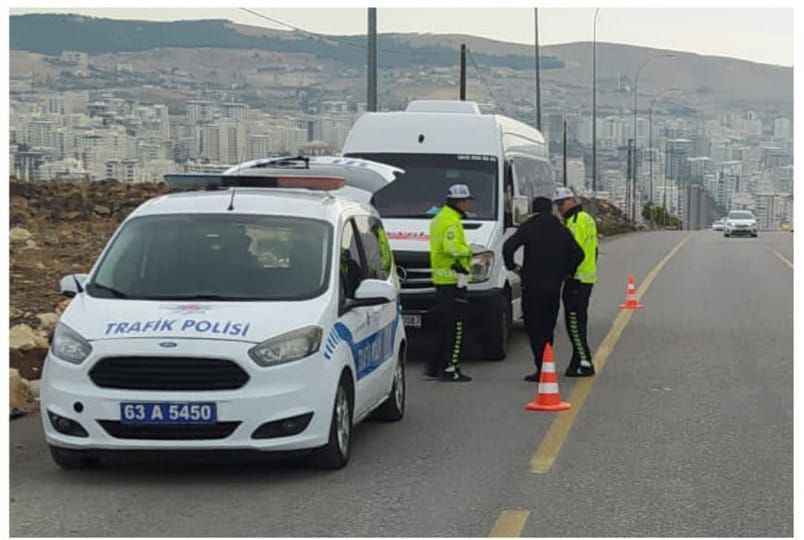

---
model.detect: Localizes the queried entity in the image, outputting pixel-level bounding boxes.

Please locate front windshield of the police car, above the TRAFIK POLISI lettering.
[86,214,332,301]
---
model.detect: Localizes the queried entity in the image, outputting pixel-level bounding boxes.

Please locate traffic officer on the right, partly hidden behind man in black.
[553,187,598,377]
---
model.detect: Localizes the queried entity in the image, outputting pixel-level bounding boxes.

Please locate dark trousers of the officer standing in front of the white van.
[427,285,466,376]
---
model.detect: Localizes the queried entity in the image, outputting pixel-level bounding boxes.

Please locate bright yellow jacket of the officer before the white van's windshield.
[430,205,472,285]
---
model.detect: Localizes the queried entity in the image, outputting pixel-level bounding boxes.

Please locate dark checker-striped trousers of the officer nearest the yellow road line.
[562,279,595,376]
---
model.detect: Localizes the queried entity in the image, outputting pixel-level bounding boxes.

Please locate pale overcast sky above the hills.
[11,7,794,66]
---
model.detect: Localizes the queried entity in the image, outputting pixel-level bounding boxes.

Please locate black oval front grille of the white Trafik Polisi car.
[89,356,249,391]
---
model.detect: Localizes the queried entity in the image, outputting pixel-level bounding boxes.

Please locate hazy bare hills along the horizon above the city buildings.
[10,14,793,108]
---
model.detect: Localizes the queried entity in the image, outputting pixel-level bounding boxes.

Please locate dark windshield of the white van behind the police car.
[349,154,497,220]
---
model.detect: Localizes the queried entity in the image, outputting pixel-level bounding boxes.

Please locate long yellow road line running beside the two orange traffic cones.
[530,235,690,474]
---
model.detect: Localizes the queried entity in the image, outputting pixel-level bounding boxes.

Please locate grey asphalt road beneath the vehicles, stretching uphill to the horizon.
[10,231,793,536]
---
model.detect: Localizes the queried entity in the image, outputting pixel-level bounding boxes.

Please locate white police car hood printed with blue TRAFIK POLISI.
[61,293,324,343]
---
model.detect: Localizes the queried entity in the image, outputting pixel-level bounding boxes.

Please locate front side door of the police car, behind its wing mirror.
[335,219,376,417]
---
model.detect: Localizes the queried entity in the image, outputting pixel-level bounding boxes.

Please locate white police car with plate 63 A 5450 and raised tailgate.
[41,158,405,468]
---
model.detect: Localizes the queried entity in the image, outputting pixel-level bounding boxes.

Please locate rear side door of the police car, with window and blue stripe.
[355,215,399,403]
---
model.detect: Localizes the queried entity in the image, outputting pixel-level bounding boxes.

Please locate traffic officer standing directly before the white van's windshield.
[426,184,473,382]
